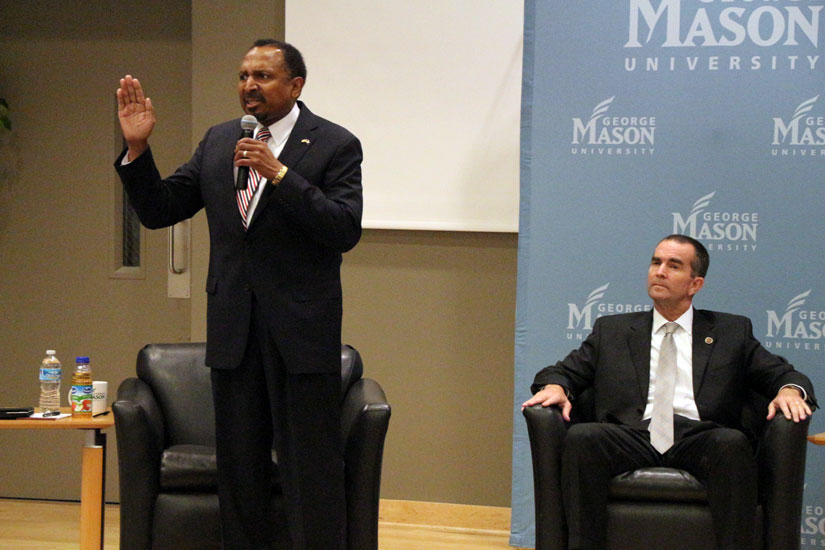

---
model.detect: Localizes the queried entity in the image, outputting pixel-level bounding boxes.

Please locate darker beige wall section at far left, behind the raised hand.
[0,0,191,499]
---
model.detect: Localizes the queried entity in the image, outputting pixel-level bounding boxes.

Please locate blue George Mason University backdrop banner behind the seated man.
[511,0,825,548]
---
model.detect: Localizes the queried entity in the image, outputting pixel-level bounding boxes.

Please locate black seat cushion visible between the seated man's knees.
[608,467,708,502]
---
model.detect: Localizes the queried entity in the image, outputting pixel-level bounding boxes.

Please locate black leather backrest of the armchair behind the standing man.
[137,342,364,446]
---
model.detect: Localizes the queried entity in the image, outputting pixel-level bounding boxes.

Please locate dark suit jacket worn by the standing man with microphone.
[115,102,362,373]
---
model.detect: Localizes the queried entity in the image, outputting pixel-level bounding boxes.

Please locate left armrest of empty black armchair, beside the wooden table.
[112,378,163,550]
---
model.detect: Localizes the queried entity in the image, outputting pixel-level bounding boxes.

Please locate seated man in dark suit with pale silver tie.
[522,235,816,550]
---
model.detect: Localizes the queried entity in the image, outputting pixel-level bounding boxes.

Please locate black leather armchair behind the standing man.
[112,343,390,550]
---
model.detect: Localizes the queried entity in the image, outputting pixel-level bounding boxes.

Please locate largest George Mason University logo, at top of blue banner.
[623,0,825,73]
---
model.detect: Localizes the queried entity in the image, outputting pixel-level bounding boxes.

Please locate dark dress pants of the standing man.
[212,304,346,550]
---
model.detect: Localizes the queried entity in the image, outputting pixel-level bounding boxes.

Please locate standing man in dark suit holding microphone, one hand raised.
[115,39,362,550]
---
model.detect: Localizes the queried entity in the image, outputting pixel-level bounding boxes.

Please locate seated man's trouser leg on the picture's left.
[561,423,661,550]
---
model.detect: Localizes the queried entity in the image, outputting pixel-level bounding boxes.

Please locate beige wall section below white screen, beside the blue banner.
[343,231,517,506]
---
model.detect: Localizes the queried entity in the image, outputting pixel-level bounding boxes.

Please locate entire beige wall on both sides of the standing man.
[0,0,517,506]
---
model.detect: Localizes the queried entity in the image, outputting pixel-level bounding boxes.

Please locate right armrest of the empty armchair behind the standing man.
[341,378,391,550]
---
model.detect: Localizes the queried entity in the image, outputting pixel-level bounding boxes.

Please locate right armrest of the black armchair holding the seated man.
[756,413,811,550]
